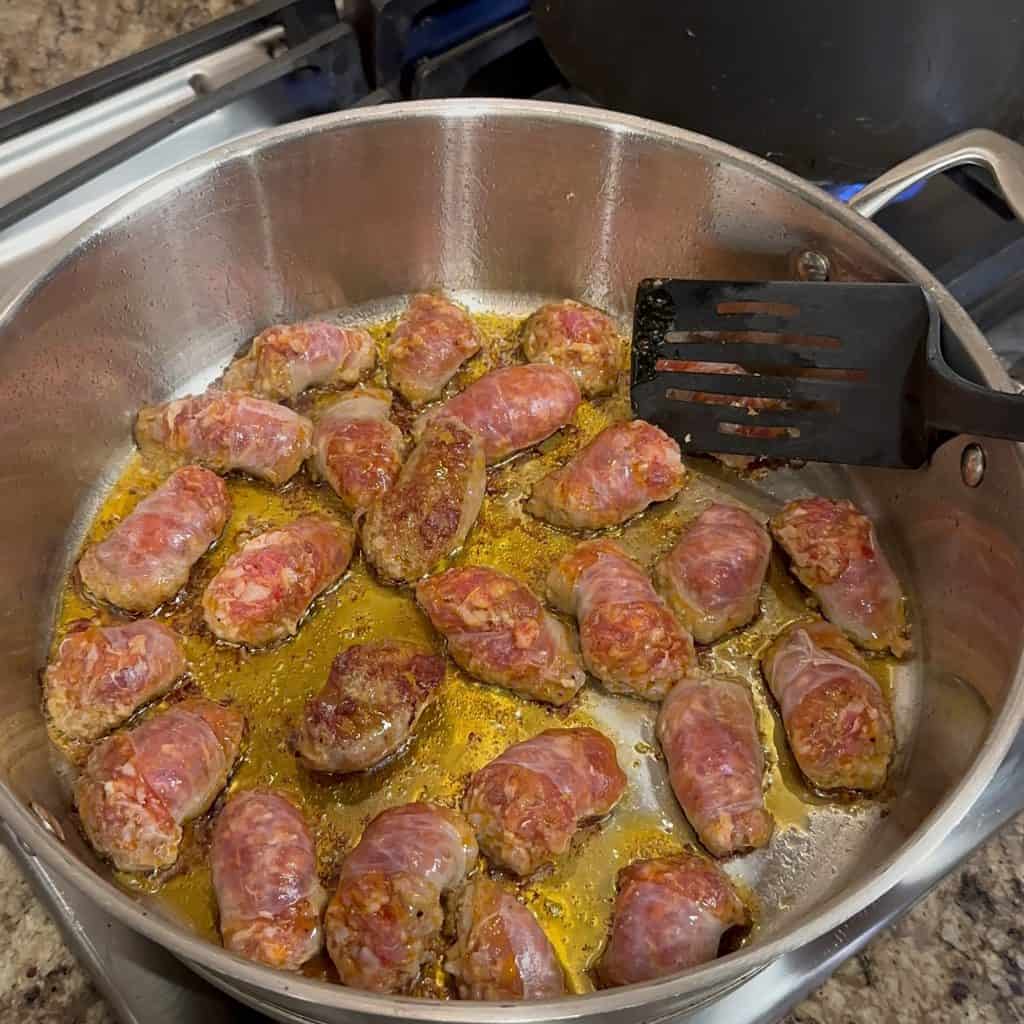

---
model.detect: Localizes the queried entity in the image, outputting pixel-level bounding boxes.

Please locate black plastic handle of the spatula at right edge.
[926,331,1024,441]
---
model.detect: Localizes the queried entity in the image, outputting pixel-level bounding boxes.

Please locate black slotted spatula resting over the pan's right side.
[632,279,1024,469]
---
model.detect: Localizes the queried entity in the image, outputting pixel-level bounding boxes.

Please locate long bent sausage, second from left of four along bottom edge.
[324,803,477,992]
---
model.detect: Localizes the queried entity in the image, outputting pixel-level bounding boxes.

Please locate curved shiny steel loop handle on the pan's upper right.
[849,128,1024,220]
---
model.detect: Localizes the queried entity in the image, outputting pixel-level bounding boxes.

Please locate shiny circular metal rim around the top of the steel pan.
[0,99,1024,1024]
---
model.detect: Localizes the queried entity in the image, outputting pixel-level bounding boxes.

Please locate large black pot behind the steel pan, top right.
[534,0,1024,182]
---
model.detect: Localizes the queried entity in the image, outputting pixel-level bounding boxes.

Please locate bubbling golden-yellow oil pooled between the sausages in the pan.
[54,313,892,996]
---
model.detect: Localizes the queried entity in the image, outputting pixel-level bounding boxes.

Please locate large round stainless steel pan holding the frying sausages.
[0,100,1024,1022]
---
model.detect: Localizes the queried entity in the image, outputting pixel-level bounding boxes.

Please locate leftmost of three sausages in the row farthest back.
[223,321,377,401]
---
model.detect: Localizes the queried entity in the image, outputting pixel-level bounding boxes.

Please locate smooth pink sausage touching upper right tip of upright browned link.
[413,365,580,465]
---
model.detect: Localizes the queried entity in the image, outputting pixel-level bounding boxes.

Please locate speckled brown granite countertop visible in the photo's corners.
[0,0,1024,1024]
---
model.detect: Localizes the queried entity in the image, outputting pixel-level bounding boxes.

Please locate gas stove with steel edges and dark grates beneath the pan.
[0,0,1024,1024]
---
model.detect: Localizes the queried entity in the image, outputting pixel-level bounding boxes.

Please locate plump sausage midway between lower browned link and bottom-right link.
[463,727,626,876]
